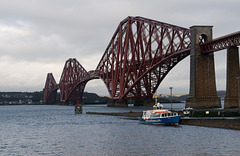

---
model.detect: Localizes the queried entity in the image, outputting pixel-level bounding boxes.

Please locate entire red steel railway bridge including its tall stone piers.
[44,16,240,108]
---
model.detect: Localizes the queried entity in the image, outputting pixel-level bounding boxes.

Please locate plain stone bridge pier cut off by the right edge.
[224,46,239,108]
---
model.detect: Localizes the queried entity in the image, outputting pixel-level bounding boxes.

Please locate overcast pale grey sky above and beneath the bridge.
[0,0,240,95]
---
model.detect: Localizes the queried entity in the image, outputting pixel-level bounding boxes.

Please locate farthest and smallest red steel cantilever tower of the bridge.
[43,73,58,104]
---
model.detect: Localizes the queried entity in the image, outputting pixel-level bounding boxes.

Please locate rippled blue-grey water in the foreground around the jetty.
[0,105,240,156]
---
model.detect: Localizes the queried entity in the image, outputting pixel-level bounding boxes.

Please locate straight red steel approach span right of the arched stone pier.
[200,31,240,53]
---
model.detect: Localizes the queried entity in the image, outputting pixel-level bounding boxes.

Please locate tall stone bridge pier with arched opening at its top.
[186,26,221,108]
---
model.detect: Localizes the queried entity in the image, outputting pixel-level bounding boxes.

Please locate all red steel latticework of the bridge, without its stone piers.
[44,17,240,102]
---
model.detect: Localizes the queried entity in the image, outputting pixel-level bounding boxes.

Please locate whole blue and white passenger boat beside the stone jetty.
[139,103,181,125]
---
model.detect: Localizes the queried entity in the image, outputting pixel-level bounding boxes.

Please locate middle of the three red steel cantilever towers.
[59,58,90,102]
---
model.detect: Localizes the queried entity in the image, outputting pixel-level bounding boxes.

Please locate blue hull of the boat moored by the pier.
[139,116,181,125]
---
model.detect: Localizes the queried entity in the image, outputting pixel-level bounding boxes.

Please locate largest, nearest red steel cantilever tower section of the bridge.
[96,17,190,100]
